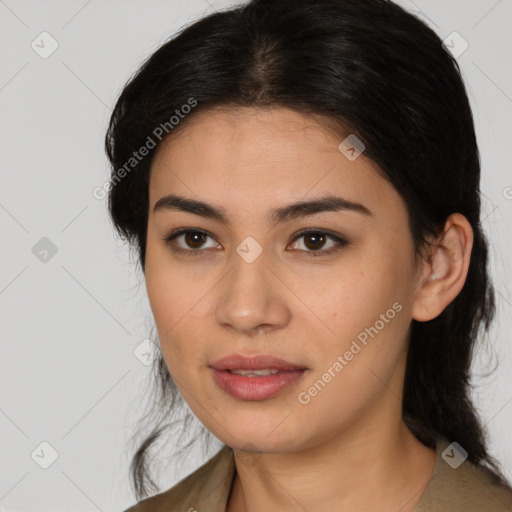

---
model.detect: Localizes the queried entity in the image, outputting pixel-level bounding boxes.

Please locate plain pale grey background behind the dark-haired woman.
[0,0,512,512]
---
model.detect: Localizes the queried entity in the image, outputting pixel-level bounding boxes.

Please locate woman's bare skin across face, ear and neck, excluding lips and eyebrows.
[145,108,473,512]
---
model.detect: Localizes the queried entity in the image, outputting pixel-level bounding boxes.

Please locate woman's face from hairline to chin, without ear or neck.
[145,108,419,452]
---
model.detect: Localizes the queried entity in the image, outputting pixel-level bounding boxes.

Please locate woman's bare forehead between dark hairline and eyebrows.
[149,108,400,222]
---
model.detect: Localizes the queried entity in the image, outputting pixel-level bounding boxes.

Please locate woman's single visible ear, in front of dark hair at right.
[412,213,473,322]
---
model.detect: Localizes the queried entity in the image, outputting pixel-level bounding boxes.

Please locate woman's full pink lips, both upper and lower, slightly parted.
[210,354,307,400]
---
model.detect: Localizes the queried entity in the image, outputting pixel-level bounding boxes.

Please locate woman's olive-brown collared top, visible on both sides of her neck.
[125,438,512,512]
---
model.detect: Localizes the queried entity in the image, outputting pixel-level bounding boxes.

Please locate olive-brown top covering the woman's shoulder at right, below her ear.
[414,439,512,512]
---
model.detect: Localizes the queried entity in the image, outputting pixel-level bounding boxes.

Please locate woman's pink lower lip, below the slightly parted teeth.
[211,368,305,400]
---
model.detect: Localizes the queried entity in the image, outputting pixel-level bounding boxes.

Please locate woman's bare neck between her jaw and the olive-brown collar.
[227,412,435,512]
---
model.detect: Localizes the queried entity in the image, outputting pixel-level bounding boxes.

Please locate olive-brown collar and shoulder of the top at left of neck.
[124,445,235,512]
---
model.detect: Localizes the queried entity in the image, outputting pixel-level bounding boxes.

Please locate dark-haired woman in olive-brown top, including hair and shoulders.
[106,0,512,512]
